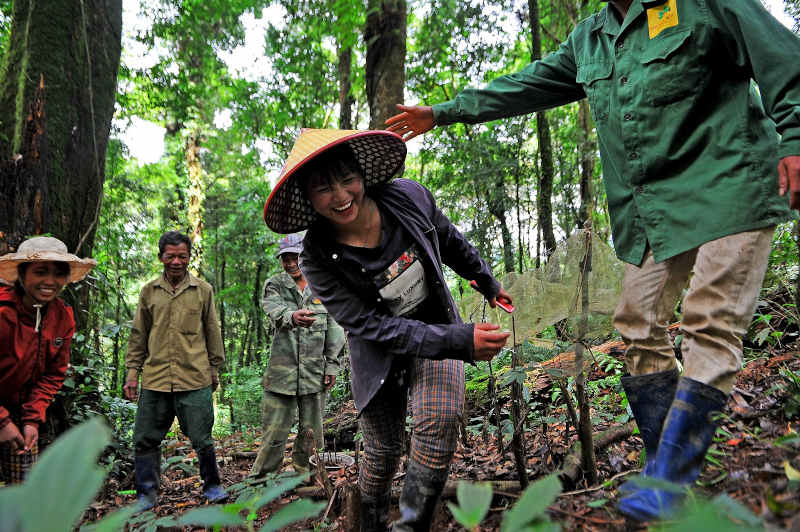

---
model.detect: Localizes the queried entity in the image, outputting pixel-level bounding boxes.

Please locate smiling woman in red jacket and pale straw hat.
[0,236,97,483]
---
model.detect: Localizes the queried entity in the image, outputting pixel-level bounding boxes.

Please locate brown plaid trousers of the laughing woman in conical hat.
[358,358,464,497]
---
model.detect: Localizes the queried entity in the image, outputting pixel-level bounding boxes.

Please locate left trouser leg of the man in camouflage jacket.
[250,391,297,477]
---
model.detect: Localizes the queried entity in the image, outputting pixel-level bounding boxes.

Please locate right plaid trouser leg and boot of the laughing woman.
[392,359,464,532]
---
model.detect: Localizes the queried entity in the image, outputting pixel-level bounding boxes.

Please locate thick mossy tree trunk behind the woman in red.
[0,0,122,338]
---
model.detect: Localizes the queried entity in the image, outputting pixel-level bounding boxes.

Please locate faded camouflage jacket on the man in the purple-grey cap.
[261,273,344,395]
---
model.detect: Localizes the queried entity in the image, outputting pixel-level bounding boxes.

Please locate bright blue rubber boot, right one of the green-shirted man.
[617,377,727,521]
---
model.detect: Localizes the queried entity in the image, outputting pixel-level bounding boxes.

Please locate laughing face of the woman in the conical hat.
[306,171,365,226]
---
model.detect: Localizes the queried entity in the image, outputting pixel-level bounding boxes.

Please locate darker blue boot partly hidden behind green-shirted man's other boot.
[617,369,679,495]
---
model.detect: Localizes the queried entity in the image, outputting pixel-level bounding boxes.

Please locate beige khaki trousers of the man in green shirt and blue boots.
[614,227,775,393]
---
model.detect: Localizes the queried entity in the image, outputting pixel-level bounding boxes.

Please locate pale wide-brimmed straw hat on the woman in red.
[0,236,97,284]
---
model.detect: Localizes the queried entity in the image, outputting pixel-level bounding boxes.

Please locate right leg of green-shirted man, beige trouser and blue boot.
[619,227,774,520]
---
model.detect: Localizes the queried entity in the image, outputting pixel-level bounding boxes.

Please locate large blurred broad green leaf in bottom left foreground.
[21,418,111,532]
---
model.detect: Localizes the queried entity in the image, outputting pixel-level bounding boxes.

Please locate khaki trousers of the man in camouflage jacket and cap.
[250,391,327,477]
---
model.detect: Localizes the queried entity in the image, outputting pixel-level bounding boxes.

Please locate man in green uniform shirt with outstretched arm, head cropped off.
[387,0,800,520]
